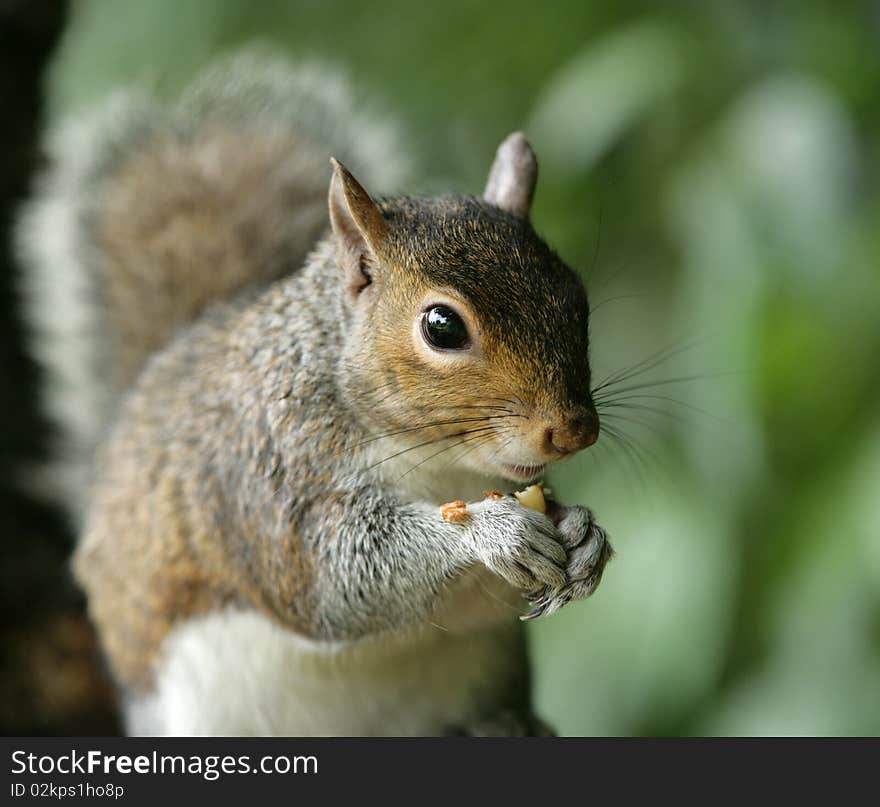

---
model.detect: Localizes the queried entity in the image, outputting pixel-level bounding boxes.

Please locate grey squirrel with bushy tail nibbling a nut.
[18,54,612,735]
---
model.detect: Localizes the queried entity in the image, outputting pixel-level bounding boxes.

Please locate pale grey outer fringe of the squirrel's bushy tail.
[15,49,411,524]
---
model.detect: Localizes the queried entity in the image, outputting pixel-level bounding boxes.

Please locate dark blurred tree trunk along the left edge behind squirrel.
[0,0,118,735]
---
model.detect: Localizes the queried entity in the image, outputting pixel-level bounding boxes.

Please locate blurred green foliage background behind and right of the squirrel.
[36,0,880,734]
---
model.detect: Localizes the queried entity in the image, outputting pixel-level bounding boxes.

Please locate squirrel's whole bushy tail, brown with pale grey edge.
[17,47,406,516]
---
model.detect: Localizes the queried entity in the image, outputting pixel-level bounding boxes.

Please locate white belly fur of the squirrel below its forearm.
[127,592,523,736]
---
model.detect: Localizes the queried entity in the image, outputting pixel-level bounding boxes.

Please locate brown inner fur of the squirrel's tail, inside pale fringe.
[92,127,326,398]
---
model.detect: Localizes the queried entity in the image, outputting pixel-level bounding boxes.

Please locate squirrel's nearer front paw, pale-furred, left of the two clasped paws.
[466,496,568,592]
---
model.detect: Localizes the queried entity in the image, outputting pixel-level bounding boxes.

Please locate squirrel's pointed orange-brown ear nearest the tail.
[328,157,388,293]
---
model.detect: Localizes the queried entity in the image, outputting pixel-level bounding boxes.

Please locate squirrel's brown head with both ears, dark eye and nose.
[329,133,599,482]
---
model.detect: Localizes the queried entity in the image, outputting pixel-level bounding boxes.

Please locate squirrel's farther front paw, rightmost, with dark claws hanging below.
[522,503,614,620]
